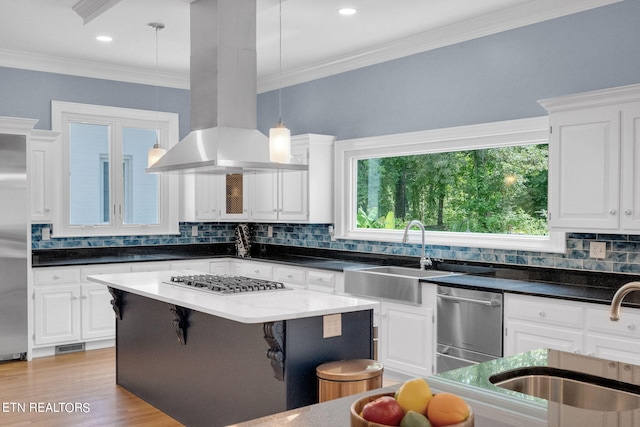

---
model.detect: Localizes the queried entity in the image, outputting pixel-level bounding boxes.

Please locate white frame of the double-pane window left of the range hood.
[51,101,179,237]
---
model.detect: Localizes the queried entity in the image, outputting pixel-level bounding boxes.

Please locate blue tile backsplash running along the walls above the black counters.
[31,222,640,274]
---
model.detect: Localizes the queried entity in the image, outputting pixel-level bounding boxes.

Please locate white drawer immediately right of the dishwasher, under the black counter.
[505,295,584,329]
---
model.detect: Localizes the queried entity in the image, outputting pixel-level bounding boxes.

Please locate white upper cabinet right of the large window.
[540,85,640,232]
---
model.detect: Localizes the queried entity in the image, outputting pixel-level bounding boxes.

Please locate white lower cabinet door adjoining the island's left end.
[80,283,116,340]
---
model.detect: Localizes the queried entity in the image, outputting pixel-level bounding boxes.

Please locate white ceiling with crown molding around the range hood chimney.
[0,0,620,91]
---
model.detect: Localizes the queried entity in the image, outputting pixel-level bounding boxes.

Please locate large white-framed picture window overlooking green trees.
[336,117,565,252]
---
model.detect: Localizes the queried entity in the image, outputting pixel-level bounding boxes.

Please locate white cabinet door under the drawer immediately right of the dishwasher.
[504,319,584,356]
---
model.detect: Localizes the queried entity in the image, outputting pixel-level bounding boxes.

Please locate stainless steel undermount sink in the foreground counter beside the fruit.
[489,367,640,412]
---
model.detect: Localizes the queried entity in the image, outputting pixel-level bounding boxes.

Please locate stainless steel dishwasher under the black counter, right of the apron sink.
[436,286,503,372]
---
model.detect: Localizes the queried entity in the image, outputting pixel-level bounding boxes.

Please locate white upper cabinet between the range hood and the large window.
[249,134,335,223]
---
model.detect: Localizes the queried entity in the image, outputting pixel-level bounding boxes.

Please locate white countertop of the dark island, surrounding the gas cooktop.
[87,270,379,323]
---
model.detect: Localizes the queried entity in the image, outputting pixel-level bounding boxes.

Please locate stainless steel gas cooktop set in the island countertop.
[165,274,290,295]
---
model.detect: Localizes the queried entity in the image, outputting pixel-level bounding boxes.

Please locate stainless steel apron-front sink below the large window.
[344,266,456,304]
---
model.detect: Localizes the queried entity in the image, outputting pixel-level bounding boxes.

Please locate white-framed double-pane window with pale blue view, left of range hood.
[52,102,178,236]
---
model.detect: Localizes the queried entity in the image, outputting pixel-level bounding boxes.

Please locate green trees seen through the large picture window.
[357,144,548,236]
